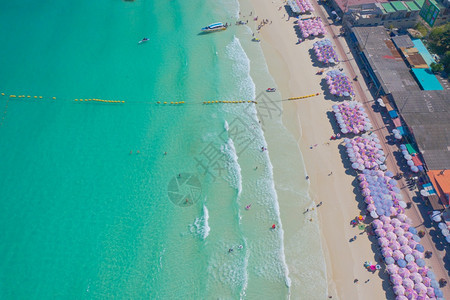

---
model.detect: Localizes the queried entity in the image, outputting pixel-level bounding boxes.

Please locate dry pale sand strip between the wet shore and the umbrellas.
[241,0,392,299]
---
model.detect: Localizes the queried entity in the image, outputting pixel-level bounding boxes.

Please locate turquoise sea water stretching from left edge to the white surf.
[0,0,296,299]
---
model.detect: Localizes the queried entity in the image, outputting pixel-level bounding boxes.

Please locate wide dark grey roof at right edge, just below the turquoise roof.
[391,90,450,173]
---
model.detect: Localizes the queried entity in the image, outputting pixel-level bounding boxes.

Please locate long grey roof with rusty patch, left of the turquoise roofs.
[352,26,420,94]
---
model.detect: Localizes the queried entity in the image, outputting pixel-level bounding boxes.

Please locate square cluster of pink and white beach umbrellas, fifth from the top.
[332,101,372,134]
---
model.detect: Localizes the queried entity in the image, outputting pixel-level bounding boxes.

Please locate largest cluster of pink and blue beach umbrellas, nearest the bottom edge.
[372,214,443,299]
